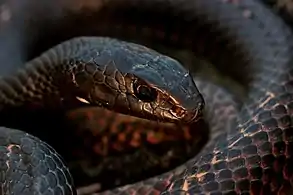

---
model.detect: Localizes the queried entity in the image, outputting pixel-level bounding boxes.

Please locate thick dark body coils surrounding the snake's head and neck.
[0,0,293,194]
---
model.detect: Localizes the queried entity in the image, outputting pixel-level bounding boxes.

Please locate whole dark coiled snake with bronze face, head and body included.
[0,0,293,195]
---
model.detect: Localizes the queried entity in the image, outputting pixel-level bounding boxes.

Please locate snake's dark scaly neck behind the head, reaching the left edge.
[0,40,90,109]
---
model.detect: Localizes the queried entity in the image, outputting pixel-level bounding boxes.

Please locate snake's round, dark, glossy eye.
[133,82,158,102]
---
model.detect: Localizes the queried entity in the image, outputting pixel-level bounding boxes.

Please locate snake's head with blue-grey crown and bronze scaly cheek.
[71,37,204,123]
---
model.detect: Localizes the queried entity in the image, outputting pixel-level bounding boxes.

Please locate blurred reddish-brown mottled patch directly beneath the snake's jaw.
[68,108,192,156]
